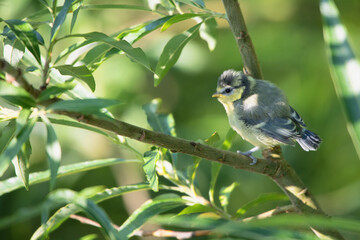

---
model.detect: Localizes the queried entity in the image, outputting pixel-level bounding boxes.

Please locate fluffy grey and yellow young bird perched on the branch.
[212,70,321,165]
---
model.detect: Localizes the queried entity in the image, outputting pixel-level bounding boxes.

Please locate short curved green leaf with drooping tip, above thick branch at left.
[54,65,95,92]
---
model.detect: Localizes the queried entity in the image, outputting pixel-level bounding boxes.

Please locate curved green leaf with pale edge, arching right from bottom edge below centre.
[119,194,186,239]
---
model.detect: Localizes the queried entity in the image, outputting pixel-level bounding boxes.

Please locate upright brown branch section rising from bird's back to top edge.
[223,0,264,79]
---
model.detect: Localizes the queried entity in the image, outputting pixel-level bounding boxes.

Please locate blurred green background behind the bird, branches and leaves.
[0,0,360,239]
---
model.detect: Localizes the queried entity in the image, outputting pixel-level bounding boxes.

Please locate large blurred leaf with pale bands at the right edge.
[320,0,360,161]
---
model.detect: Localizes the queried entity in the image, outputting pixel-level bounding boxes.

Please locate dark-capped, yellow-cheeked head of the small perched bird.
[212,70,255,104]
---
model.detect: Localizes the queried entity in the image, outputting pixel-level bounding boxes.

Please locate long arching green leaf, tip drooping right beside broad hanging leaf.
[69,32,152,71]
